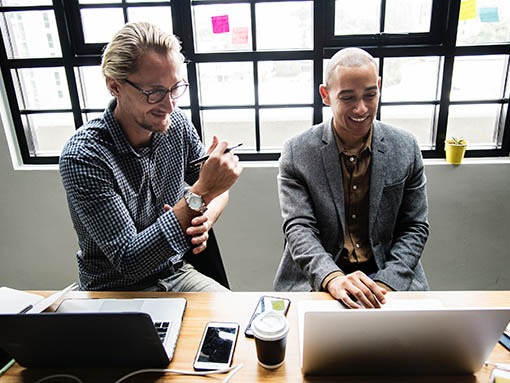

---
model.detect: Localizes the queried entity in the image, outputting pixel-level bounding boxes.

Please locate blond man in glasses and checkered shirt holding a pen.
[60,22,242,291]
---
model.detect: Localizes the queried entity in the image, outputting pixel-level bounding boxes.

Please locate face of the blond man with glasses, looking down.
[108,51,182,147]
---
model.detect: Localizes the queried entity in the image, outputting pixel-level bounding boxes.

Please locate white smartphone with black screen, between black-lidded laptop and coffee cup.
[193,322,239,370]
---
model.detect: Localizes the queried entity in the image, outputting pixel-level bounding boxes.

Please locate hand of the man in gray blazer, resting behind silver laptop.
[326,271,387,309]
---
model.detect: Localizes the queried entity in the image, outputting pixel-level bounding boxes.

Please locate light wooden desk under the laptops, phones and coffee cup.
[0,291,510,383]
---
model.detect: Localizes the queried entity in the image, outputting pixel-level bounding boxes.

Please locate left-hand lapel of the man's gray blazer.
[320,120,345,230]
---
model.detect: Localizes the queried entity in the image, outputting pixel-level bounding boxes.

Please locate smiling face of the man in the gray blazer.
[319,64,381,146]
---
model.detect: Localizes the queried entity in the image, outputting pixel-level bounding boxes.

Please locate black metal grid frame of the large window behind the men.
[0,0,510,164]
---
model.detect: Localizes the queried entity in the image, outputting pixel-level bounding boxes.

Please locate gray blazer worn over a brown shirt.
[274,121,429,291]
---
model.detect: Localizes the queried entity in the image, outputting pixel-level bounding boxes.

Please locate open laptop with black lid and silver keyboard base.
[0,298,186,368]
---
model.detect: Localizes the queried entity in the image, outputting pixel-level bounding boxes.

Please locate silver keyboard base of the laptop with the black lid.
[57,298,186,360]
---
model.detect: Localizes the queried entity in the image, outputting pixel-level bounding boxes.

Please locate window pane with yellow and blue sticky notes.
[457,0,510,45]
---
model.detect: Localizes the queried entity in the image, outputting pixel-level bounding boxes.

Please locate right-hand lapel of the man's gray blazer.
[368,121,387,233]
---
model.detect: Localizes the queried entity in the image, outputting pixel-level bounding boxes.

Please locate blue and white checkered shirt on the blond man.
[59,100,205,290]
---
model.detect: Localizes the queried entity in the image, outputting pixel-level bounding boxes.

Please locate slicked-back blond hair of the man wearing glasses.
[101,22,184,80]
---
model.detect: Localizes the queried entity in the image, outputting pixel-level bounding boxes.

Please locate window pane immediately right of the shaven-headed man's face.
[381,57,440,102]
